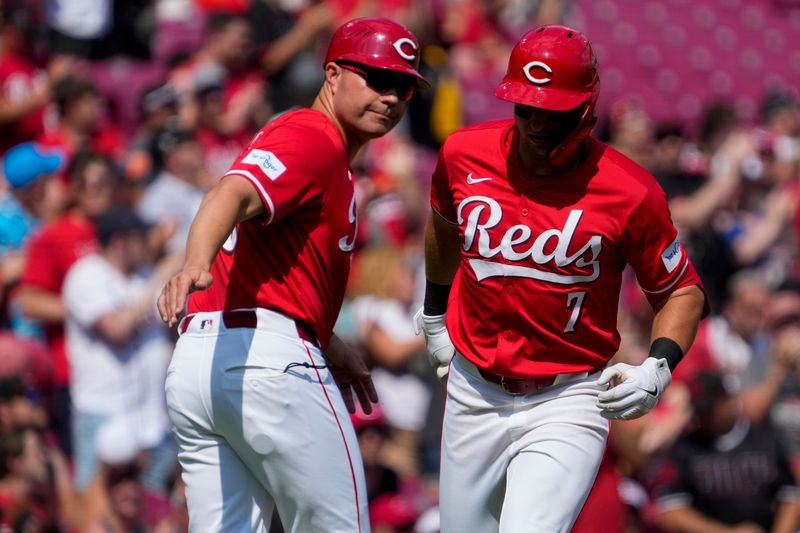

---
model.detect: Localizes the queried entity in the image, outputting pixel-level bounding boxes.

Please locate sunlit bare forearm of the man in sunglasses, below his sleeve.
[184,176,264,270]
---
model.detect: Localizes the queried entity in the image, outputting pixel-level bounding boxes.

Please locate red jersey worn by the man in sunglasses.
[189,109,357,346]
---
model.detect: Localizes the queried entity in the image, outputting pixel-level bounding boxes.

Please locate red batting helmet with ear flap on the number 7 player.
[494,25,599,162]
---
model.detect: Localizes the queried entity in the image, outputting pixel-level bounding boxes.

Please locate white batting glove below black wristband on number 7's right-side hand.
[597,357,672,420]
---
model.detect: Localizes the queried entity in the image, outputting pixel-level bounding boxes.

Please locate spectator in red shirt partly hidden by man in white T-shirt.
[19,153,115,454]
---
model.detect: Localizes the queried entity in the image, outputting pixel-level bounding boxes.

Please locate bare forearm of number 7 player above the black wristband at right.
[651,285,705,354]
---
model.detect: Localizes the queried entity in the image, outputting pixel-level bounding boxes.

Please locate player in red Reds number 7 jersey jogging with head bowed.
[418,26,707,533]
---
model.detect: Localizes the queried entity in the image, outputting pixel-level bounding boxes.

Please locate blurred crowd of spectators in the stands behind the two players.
[0,0,800,533]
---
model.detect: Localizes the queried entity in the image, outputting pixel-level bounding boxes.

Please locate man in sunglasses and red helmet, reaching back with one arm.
[158,18,428,533]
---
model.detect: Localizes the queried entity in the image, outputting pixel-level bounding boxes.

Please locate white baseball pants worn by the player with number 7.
[439,354,608,533]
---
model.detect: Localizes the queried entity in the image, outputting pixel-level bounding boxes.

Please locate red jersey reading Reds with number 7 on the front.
[431,120,700,378]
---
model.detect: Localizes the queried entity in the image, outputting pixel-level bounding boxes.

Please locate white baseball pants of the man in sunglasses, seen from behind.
[166,309,370,533]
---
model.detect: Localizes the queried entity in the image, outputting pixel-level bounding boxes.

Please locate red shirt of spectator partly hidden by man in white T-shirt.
[21,213,97,385]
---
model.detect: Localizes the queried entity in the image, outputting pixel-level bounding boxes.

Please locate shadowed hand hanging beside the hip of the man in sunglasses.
[325,335,378,414]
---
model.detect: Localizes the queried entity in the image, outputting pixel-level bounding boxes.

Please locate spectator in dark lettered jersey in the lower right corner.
[644,373,800,533]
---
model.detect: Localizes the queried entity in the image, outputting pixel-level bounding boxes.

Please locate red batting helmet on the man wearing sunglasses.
[325,18,430,89]
